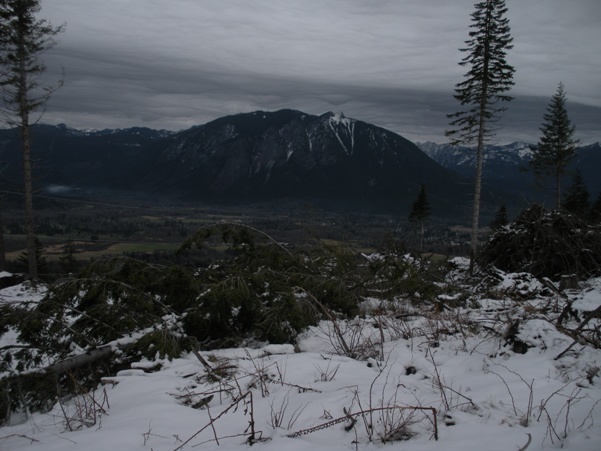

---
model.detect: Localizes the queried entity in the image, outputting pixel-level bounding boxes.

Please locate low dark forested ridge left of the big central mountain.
[0,124,170,191]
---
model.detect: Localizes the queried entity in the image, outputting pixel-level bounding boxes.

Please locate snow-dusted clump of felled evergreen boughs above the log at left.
[11,257,193,370]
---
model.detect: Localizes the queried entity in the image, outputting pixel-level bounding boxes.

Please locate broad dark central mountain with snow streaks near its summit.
[145,110,474,215]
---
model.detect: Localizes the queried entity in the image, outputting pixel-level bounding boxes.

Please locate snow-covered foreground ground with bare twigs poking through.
[0,270,601,451]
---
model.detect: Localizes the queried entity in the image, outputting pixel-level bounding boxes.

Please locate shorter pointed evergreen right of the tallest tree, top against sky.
[530,83,579,210]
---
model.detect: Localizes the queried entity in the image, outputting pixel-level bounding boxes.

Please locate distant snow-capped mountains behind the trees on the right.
[416,142,601,205]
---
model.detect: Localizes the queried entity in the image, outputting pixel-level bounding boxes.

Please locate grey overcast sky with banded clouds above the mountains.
[40,0,601,143]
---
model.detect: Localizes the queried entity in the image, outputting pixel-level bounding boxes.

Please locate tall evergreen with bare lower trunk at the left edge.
[0,0,63,280]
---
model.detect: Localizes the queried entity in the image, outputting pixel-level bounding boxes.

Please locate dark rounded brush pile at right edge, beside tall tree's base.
[480,205,601,280]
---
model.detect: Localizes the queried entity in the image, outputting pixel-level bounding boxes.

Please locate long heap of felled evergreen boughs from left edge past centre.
[0,224,454,416]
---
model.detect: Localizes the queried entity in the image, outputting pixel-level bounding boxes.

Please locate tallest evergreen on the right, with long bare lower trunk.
[447,0,515,272]
